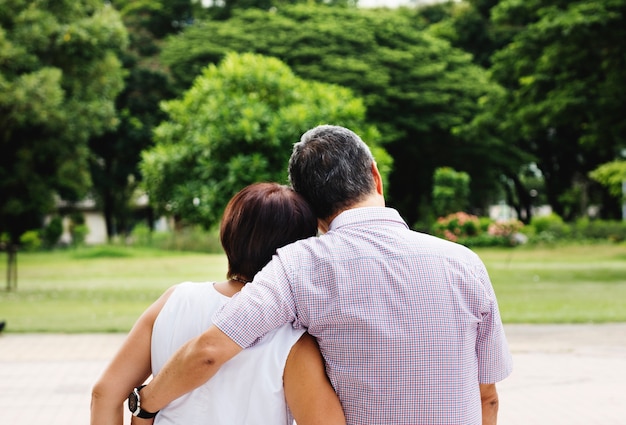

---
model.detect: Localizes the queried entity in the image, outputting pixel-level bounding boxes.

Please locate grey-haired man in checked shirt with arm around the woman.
[135,126,512,425]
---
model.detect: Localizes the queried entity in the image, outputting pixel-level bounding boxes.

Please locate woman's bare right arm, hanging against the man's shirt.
[283,333,346,425]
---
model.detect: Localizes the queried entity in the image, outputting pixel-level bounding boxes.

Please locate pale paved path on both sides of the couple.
[0,324,626,425]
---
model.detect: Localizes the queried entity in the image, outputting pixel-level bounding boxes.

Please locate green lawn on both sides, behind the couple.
[0,244,626,333]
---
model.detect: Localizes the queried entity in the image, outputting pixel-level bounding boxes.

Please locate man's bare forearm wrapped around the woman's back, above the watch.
[138,326,242,416]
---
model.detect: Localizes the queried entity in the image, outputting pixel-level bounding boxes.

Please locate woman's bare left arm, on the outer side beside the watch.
[91,286,175,425]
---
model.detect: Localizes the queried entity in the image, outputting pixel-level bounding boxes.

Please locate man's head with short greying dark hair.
[289,125,376,219]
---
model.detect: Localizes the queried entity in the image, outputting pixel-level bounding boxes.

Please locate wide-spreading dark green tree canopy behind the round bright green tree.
[163,5,506,222]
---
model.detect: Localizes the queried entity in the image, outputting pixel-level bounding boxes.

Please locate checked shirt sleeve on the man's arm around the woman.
[213,256,299,348]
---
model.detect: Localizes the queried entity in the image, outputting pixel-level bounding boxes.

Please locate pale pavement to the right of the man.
[498,324,626,425]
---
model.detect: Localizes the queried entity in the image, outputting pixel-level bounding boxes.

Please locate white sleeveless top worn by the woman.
[152,282,304,425]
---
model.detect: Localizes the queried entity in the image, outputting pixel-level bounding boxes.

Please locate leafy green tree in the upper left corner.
[0,0,127,288]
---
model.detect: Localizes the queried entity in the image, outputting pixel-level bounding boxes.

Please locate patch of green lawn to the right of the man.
[477,244,626,323]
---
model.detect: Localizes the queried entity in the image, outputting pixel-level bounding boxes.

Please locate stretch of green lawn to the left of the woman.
[0,247,226,333]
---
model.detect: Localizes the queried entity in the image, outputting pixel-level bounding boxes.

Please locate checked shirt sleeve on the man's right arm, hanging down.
[476,260,513,384]
